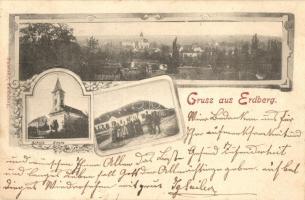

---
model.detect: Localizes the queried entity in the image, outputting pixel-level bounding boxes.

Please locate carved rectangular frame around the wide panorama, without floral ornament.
[10,13,294,90]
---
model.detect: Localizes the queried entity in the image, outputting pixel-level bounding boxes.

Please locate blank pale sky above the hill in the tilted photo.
[93,80,174,118]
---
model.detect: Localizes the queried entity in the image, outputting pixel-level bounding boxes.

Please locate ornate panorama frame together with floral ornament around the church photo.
[9,13,295,152]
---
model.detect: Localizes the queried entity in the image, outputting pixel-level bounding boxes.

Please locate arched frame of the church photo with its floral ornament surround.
[9,69,97,153]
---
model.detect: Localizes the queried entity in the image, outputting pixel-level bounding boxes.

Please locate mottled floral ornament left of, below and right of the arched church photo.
[9,69,121,153]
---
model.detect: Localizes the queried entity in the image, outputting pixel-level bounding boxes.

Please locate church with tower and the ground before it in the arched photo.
[28,79,89,139]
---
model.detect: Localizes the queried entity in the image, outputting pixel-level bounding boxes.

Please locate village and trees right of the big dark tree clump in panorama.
[82,32,281,81]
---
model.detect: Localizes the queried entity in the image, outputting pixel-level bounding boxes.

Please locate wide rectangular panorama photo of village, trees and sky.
[19,21,282,81]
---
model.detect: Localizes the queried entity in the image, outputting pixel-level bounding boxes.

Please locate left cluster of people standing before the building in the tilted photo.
[111,115,144,142]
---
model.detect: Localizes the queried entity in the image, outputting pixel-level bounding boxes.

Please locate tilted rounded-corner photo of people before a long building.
[94,76,181,150]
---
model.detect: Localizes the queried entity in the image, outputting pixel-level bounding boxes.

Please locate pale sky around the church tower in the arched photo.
[26,72,90,122]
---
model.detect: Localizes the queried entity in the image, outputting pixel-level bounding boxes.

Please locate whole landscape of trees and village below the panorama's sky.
[19,24,282,81]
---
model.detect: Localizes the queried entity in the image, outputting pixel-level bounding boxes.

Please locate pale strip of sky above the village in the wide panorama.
[69,22,282,37]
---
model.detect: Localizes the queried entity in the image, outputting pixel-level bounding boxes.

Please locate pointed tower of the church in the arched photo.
[51,78,65,112]
